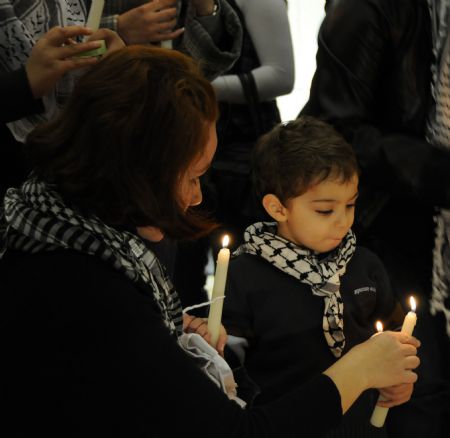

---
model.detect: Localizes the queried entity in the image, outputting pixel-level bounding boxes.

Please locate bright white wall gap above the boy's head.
[277,0,325,121]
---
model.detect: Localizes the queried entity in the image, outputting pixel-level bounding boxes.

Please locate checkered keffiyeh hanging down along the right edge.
[427,0,450,336]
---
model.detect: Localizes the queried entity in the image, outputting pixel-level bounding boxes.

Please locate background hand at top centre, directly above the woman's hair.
[117,0,184,44]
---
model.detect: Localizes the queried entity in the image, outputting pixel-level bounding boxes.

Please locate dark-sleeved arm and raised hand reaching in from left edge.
[0,26,124,199]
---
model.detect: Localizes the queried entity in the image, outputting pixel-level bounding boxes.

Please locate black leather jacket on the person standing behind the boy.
[301,0,450,297]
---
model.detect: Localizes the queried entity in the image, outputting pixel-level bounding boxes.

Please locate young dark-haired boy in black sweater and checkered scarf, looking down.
[223,117,412,438]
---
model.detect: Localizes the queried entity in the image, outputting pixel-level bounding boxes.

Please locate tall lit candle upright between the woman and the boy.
[208,235,230,346]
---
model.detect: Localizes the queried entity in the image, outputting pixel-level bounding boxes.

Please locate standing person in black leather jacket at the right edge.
[301,0,450,438]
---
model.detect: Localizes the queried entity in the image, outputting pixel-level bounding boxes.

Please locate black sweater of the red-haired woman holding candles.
[0,250,341,438]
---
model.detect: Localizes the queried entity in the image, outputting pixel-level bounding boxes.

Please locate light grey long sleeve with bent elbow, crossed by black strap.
[213,0,295,103]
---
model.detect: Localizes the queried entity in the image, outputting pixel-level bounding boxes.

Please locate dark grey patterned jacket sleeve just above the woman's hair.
[176,0,242,80]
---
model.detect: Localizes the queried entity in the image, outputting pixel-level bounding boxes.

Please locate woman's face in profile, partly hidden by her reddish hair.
[180,122,217,210]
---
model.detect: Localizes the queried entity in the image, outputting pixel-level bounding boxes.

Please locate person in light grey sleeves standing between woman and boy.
[175,0,295,312]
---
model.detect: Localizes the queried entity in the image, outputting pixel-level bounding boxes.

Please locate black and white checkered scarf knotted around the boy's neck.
[235,222,356,357]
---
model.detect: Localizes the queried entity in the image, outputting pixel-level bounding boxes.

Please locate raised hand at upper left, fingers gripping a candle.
[25,26,100,98]
